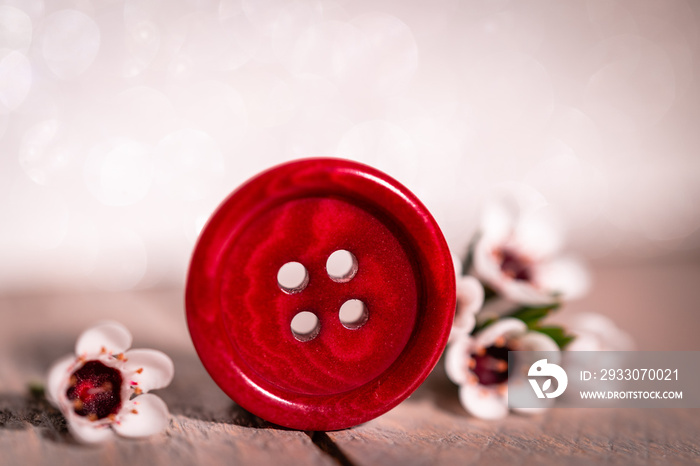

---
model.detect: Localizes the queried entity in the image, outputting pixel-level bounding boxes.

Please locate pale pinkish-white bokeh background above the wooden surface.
[0,0,700,290]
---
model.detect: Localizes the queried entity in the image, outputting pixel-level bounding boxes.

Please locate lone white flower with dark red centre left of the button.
[46,322,174,443]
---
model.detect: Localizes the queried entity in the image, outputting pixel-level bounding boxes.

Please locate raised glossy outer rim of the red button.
[185,158,456,430]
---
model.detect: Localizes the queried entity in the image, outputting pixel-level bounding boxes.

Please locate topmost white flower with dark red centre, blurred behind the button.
[472,196,589,305]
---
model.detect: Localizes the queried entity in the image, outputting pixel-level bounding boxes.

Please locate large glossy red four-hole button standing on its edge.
[186,159,455,430]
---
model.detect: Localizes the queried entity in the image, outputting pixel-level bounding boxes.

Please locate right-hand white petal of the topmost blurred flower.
[536,258,590,300]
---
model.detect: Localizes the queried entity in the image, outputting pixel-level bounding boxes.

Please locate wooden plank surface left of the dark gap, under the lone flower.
[0,291,336,466]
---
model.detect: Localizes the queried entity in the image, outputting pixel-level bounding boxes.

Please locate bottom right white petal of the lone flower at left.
[112,394,170,437]
